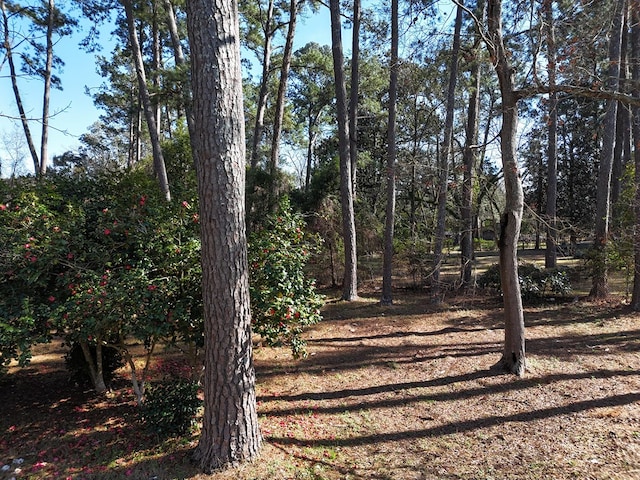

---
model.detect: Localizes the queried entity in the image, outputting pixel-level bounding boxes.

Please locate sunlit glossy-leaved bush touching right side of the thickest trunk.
[249,198,324,357]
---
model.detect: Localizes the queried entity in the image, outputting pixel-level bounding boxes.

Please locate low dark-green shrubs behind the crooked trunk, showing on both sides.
[478,263,571,300]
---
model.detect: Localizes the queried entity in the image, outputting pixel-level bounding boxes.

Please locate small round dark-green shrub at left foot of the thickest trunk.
[141,378,202,437]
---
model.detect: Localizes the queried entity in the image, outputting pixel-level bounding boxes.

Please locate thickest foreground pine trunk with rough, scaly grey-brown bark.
[187,0,262,472]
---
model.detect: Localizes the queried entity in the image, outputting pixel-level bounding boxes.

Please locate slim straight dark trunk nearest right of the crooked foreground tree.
[543,0,558,268]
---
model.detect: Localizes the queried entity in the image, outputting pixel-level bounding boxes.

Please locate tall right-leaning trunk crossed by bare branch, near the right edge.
[589,0,625,298]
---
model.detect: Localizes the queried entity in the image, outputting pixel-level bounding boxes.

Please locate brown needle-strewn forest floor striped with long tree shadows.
[0,249,640,480]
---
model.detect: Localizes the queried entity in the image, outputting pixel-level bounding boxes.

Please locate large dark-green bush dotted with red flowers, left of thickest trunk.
[0,171,202,386]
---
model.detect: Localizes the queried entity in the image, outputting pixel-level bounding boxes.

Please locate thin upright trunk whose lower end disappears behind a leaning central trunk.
[349,0,360,193]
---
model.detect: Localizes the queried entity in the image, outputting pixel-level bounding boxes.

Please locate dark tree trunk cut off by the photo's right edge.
[630,0,640,311]
